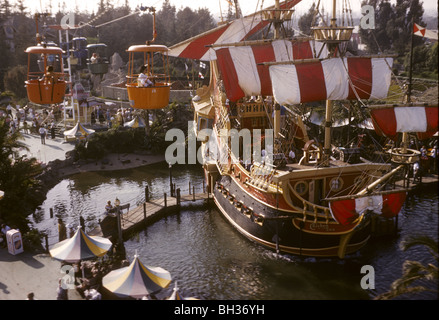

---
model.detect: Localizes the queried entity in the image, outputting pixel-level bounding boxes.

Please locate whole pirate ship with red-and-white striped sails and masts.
[169,0,437,258]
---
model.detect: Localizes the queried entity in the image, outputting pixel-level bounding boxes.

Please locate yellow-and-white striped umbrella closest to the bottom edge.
[102,255,171,299]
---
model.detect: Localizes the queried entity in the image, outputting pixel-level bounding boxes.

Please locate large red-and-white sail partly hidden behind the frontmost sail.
[216,40,326,101]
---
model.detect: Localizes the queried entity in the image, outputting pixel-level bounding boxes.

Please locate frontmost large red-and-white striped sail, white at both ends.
[270,57,393,104]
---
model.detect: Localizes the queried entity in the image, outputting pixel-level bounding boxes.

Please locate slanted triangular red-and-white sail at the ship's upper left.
[169,0,301,61]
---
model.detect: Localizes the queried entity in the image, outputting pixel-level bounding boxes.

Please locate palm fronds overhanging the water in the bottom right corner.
[375,236,439,300]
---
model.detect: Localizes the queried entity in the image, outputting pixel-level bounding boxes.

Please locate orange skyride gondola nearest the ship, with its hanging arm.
[126,8,171,109]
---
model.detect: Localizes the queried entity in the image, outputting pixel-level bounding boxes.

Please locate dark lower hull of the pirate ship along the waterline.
[213,171,370,257]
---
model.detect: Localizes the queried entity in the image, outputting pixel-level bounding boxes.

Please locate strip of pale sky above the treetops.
[17,0,438,18]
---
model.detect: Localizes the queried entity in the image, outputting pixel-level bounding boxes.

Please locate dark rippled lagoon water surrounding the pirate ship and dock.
[33,164,438,300]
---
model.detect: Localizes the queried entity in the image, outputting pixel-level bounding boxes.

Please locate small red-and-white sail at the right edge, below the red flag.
[370,104,439,140]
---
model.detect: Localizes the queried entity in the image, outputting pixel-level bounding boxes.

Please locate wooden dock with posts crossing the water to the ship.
[88,190,211,239]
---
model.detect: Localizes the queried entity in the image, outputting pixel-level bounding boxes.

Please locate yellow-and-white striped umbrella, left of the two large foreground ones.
[49,228,112,263]
